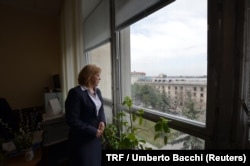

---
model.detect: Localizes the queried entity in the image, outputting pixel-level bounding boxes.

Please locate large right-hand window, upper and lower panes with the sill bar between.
[118,0,208,149]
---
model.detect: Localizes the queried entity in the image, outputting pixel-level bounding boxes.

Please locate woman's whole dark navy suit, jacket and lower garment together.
[65,86,106,166]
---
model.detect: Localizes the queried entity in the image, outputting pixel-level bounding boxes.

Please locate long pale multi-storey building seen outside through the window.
[131,72,207,122]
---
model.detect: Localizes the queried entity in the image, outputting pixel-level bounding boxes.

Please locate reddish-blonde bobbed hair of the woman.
[78,64,101,86]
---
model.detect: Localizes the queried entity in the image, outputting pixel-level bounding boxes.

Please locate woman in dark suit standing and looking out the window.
[65,65,106,166]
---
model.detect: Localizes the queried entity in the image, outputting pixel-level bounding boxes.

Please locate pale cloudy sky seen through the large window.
[130,0,207,76]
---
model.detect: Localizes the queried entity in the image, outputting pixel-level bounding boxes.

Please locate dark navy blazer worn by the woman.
[65,86,106,142]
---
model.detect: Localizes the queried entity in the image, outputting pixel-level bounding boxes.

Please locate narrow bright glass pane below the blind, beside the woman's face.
[88,43,112,100]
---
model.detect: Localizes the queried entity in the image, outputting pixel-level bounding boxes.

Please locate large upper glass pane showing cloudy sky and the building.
[130,0,207,123]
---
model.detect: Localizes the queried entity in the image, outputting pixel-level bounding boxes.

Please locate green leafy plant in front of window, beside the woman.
[102,96,170,150]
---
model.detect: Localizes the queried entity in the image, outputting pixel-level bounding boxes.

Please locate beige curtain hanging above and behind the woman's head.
[60,0,85,97]
